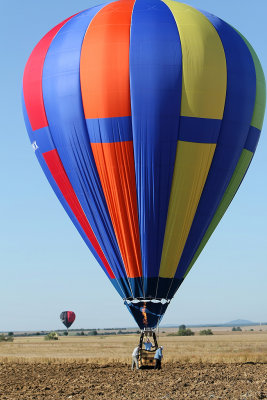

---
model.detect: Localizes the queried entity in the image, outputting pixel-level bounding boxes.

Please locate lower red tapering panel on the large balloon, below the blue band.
[43,149,115,279]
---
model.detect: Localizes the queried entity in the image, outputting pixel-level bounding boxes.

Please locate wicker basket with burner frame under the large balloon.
[138,328,158,369]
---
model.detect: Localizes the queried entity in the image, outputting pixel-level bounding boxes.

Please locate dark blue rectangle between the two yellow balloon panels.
[178,116,222,143]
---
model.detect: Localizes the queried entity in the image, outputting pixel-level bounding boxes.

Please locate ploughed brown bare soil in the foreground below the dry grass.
[0,361,267,400]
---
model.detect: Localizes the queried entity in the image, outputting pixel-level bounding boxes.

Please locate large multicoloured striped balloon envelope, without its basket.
[23,0,266,329]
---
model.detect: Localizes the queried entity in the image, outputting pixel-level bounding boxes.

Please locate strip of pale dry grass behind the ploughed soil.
[0,332,267,364]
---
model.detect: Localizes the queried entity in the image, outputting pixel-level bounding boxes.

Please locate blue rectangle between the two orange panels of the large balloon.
[86,117,133,143]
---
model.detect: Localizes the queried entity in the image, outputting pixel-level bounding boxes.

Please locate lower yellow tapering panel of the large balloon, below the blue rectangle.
[159,141,216,278]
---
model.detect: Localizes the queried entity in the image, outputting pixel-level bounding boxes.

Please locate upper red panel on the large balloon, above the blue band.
[23,14,77,131]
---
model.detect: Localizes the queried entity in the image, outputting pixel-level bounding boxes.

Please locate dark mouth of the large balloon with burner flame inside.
[124,298,170,330]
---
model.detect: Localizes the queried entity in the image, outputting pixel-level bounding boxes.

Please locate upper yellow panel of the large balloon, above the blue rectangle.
[164,0,227,119]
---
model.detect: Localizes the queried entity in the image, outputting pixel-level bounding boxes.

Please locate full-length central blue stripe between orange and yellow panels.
[130,0,182,297]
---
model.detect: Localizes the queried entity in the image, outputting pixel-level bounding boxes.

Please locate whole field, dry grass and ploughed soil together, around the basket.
[0,333,267,400]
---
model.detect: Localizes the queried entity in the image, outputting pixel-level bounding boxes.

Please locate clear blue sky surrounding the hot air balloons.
[0,0,267,331]
